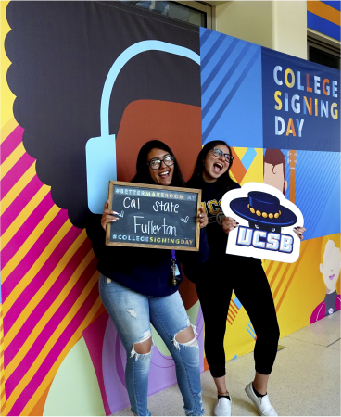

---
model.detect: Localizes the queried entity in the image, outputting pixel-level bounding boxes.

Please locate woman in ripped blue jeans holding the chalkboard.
[87,140,208,416]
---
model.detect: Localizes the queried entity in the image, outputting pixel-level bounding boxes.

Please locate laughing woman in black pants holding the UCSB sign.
[187,141,305,416]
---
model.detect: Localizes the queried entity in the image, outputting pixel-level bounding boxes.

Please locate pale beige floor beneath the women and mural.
[113,311,341,416]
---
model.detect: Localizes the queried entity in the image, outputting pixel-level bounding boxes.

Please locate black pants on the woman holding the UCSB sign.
[196,255,279,378]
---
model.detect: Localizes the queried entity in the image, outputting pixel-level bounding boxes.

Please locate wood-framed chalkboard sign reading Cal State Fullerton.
[106,181,201,251]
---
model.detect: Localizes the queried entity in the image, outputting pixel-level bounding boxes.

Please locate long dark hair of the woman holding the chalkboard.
[132,139,185,187]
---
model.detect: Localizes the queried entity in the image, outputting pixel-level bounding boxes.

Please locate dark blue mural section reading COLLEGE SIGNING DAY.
[262,48,340,152]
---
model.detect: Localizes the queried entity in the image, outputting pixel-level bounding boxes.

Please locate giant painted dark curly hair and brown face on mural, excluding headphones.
[6,2,201,228]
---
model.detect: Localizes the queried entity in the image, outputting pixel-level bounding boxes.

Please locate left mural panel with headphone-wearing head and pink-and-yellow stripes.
[1,1,201,415]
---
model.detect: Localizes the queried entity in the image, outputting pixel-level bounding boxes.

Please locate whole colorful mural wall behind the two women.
[0,1,340,415]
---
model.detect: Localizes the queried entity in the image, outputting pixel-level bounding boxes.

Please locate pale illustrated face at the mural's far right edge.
[320,240,341,293]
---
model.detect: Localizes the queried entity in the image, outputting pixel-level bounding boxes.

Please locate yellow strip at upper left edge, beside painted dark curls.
[0,1,16,131]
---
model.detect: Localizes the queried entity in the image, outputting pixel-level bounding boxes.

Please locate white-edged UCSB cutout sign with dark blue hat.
[221,183,303,263]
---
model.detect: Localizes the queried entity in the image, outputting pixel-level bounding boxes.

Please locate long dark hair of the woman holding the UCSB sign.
[186,140,236,193]
